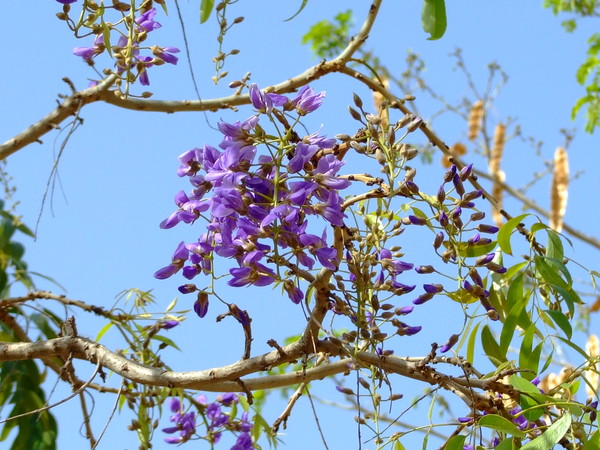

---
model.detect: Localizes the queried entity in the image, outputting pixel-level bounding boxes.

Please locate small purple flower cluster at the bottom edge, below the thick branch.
[163,393,254,450]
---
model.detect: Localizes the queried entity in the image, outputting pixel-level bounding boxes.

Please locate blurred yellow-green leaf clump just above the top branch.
[302,9,352,58]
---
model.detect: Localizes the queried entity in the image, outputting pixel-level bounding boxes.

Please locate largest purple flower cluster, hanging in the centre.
[155,85,350,314]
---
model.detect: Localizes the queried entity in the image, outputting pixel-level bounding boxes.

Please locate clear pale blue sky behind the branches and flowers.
[0,0,600,449]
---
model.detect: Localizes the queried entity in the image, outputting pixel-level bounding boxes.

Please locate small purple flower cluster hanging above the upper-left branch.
[70,8,179,86]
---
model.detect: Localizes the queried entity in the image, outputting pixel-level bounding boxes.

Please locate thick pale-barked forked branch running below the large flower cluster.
[0,336,506,408]
